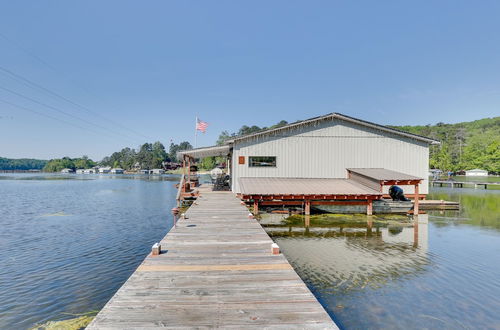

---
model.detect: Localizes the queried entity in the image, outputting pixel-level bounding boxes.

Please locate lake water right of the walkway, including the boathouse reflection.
[264,188,500,329]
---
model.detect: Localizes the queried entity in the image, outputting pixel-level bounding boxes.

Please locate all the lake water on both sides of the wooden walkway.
[0,174,500,329]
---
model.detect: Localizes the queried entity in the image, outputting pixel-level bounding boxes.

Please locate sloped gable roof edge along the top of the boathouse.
[226,112,440,144]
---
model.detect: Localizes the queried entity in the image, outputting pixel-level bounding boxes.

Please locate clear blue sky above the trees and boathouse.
[0,0,500,160]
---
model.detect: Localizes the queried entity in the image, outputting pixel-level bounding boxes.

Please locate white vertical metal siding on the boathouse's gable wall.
[232,119,429,194]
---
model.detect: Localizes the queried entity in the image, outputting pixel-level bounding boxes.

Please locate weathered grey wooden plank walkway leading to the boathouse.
[87,188,337,329]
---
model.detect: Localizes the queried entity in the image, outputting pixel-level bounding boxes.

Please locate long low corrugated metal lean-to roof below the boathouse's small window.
[239,178,381,196]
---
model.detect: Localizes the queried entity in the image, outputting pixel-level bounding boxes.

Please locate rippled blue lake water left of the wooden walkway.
[0,174,178,329]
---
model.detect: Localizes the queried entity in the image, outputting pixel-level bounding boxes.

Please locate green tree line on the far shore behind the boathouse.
[0,117,500,173]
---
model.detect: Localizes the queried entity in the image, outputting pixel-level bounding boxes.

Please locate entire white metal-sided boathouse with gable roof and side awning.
[178,113,439,213]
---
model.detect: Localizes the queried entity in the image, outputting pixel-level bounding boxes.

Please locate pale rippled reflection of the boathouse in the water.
[261,215,429,291]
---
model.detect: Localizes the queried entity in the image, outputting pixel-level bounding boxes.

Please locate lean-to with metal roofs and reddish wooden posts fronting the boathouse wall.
[239,168,422,215]
